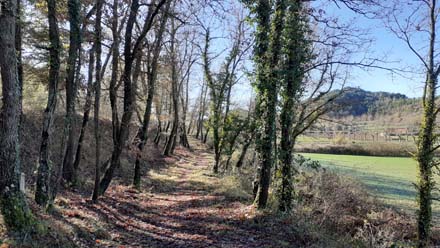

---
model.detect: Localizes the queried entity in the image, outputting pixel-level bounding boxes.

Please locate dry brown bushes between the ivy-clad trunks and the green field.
[297,171,416,247]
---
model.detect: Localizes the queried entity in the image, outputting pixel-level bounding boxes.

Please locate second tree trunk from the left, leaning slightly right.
[35,0,61,206]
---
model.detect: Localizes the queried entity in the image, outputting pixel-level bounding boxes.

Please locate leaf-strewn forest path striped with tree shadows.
[57,141,300,248]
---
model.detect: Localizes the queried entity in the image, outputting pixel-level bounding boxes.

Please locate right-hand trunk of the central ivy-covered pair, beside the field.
[278,1,309,211]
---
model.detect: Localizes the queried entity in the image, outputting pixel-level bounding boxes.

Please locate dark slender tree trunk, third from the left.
[62,0,81,184]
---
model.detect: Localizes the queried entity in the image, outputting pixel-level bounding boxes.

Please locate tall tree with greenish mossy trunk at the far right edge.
[372,0,440,245]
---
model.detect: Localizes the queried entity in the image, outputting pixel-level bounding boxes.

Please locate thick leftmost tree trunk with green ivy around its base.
[0,0,34,231]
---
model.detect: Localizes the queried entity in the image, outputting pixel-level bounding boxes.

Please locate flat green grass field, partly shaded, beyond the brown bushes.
[302,153,440,223]
